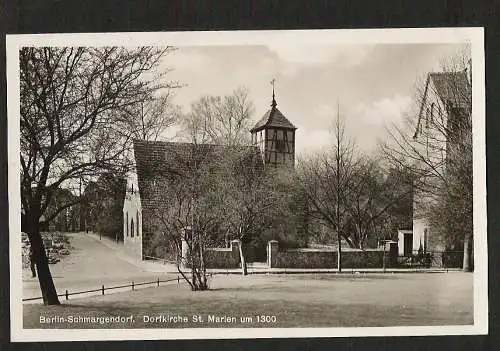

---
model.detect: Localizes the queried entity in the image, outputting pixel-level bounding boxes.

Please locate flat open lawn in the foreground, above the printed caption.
[24,273,473,329]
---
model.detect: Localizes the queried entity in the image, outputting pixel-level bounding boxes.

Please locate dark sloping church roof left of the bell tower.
[134,140,263,213]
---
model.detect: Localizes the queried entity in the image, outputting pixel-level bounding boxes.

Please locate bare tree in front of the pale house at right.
[382,48,473,270]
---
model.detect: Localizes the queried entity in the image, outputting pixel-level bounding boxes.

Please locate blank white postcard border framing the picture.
[6,27,488,342]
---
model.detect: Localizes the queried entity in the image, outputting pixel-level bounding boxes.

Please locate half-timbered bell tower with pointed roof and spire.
[250,79,297,168]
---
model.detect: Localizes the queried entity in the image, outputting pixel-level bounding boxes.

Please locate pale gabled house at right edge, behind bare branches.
[406,61,472,255]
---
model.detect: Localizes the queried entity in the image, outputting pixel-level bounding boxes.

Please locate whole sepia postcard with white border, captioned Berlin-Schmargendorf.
[7,28,488,341]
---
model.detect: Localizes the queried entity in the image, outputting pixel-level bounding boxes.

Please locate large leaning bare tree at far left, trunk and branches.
[19,47,174,304]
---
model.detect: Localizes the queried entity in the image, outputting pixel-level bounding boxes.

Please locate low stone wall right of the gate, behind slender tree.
[267,240,397,269]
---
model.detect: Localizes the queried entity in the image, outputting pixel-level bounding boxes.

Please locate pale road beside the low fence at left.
[23,233,177,302]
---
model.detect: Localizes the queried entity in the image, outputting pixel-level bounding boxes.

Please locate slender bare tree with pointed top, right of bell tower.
[297,107,411,271]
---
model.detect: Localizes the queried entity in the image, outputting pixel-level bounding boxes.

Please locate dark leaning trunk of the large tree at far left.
[27,216,60,305]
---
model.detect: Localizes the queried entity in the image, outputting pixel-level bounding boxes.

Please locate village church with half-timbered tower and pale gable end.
[123,89,297,259]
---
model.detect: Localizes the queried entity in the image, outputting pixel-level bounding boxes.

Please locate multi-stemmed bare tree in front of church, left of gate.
[154,143,231,291]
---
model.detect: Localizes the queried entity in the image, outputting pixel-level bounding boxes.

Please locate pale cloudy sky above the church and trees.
[157,44,459,153]
